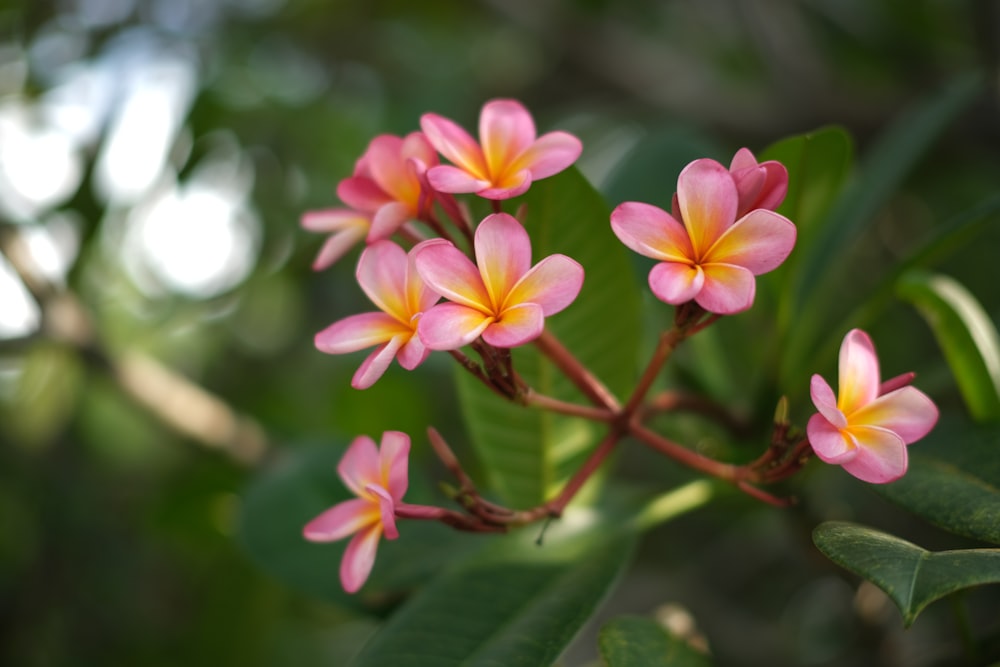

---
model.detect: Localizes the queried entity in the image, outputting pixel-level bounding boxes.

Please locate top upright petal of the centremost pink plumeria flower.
[474,213,531,310]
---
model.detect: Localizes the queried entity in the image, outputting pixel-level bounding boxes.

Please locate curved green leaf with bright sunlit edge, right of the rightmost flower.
[896,271,1000,421]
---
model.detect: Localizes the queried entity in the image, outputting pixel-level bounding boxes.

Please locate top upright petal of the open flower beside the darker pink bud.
[677,158,738,257]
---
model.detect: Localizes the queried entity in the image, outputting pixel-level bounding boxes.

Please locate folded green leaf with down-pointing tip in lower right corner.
[813,521,1000,627]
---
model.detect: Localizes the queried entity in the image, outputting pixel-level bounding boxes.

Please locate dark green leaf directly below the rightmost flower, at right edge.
[874,417,1000,544]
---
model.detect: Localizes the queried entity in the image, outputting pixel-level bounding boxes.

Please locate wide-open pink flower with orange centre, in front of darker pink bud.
[611,159,795,315]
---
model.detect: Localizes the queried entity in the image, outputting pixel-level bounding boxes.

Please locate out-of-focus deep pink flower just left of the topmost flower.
[337,132,438,243]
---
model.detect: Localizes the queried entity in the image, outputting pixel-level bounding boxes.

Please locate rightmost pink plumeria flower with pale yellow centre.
[806,329,938,484]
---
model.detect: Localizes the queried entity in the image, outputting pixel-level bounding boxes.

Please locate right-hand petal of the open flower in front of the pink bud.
[703,209,796,276]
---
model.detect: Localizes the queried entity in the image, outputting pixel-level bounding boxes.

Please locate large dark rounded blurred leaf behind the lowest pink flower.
[239,446,478,611]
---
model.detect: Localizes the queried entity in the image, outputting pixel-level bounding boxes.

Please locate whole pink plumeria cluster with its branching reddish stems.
[302,99,938,592]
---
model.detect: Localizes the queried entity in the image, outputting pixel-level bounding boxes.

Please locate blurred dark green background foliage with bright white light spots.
[0,0,1000,665]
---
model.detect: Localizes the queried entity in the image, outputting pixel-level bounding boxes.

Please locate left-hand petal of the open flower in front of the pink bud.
[611,202,695,264]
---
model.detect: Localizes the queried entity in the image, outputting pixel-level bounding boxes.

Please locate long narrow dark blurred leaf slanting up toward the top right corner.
[781,75,982,391]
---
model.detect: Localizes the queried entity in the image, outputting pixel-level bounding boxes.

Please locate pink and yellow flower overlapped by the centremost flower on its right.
[316,241,439,389]
